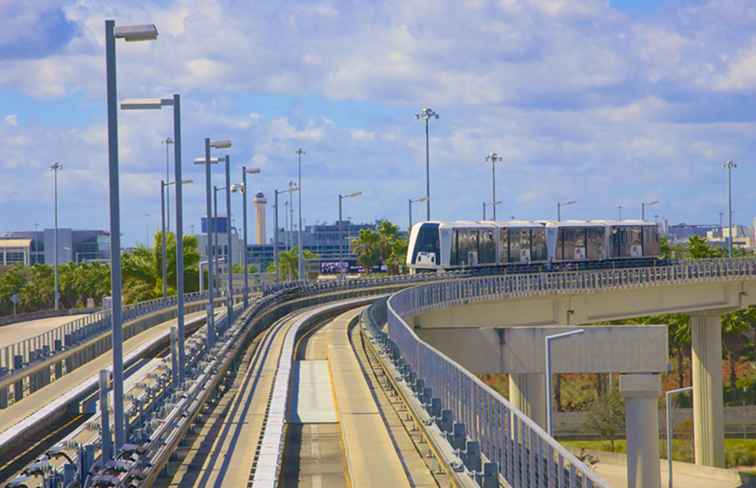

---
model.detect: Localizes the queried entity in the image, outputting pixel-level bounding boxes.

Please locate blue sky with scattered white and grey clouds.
[0,0,756,245]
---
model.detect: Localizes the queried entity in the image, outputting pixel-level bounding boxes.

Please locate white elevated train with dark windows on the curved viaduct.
[407,220,661,272]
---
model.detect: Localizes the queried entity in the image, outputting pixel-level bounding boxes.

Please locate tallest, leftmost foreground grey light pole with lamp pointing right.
[105,20,158,453]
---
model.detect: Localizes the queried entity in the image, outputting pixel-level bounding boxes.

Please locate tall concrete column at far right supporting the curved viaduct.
[690,314,724,468]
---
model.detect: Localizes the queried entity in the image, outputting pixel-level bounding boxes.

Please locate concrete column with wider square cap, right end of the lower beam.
[620,374,661,488]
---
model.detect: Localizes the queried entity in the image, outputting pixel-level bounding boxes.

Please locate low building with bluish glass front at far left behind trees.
[0,228,110,266]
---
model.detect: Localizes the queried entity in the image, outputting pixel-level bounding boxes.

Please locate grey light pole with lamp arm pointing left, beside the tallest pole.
[121,93,186,385]
